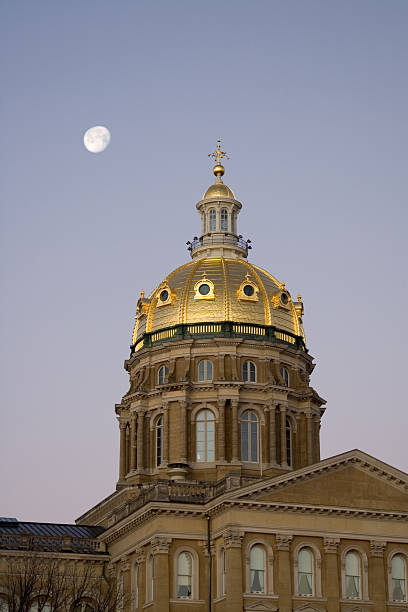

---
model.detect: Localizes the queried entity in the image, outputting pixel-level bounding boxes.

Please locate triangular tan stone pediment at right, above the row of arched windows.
[230,451,408,512]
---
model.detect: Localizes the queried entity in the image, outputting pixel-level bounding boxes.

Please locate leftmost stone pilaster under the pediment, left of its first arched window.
[224,529,244,612]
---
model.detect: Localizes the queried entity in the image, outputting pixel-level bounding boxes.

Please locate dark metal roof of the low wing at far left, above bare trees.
[0,518,104,538]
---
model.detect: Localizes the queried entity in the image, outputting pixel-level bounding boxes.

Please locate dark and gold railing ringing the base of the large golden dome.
[130,321,306,355]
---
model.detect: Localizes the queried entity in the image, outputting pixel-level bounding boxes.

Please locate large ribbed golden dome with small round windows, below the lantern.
[132,256,303,344]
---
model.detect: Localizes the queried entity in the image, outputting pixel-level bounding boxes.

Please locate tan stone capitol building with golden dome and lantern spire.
[0,142,408,612]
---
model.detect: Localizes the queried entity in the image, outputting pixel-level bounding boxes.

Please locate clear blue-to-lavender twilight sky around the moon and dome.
[0,0,408,522]
